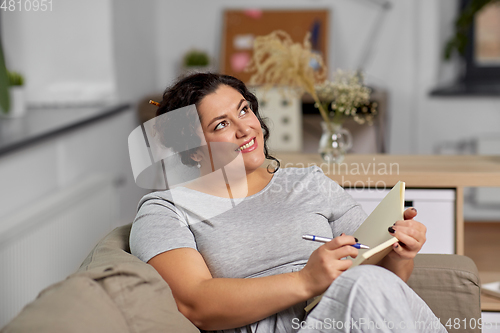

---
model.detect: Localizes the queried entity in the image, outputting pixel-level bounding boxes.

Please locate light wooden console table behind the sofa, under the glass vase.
[276,153,500,311]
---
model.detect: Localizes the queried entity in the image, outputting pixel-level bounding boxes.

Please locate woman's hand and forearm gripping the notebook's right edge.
[379,208,427,282]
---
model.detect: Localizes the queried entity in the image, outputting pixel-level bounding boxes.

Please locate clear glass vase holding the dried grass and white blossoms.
[318,121,352,163]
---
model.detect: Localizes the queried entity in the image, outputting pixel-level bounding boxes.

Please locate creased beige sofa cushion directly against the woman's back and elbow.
[77,224,199,332]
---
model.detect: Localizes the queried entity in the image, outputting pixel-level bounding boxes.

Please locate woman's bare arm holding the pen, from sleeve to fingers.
[148,236,357,330]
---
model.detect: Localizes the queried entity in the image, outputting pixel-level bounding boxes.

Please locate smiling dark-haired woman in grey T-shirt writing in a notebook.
[130,74,445,333]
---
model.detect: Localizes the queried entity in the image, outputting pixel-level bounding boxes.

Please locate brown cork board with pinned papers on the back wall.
[220,9,329,83]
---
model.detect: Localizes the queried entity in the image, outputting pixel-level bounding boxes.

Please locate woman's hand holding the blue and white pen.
[299,234,358,297]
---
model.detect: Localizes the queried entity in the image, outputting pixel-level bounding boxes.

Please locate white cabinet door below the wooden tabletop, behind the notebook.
[346,188,456,254]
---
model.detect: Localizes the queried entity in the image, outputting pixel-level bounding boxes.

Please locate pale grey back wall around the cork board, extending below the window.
[156,0,500,154]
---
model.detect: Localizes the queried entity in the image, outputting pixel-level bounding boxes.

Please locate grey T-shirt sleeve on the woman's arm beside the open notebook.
[314,166,367,236]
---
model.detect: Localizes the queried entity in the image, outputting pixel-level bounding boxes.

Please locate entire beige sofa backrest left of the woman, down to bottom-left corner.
[1,224,199,333]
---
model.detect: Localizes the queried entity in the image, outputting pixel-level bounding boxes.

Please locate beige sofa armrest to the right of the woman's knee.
[408,254,481,332]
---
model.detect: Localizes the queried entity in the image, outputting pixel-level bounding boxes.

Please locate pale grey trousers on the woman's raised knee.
[295,265,446,333]
